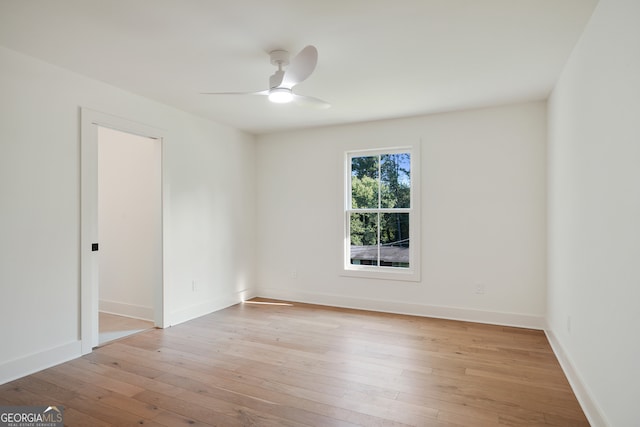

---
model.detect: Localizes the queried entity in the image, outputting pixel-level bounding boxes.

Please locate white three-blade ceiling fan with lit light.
[203,45,331,108]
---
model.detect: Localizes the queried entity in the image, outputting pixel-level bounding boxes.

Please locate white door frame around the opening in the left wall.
[80,108,165,354]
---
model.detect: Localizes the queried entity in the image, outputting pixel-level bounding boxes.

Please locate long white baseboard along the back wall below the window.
[258,288,545,330]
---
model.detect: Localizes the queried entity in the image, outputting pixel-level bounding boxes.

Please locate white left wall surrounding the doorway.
[0,48,255,383]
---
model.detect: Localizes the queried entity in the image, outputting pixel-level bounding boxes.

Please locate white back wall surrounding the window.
[257,102,546,328]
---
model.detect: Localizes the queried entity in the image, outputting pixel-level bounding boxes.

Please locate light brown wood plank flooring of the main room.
[0,299,589,427]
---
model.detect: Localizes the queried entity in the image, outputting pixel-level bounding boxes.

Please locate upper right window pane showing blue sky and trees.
[380,153,411,208]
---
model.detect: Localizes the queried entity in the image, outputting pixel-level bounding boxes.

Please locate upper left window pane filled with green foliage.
[351,156,379,209]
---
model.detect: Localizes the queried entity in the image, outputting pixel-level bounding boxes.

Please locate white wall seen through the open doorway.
[97,127,162,321]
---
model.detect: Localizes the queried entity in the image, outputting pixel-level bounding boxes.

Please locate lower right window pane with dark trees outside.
[380,213,409,268]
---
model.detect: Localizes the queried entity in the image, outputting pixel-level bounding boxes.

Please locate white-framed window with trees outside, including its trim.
[344,147,419,280]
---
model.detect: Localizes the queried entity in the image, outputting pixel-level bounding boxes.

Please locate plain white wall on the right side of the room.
[548,0,640,426]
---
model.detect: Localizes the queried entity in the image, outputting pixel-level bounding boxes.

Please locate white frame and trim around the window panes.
[342,143,421,282]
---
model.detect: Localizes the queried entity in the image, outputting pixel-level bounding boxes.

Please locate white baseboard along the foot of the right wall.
[544,327,610,427]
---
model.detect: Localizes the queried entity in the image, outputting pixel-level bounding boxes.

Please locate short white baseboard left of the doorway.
[0,341,82,384]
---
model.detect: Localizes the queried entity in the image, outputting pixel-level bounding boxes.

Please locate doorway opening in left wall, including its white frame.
[80,109,164,354]
